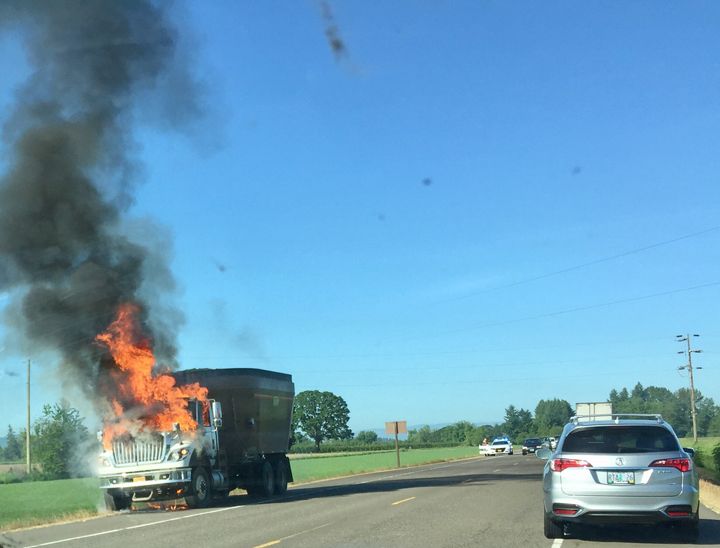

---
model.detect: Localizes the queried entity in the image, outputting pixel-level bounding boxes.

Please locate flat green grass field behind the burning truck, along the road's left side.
[0,447,478,531]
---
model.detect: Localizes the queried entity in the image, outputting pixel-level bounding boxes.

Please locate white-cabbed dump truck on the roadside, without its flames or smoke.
[99,369,294,510]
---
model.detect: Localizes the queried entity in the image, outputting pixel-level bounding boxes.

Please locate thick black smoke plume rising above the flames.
[0,0,197,406]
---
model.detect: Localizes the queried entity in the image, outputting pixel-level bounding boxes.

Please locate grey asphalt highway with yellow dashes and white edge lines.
[0,455,720,548]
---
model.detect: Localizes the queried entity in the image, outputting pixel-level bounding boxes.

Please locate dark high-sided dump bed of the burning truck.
[173,368,295,466]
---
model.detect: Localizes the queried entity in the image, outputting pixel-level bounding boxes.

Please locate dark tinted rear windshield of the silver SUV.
[562,426,680,453]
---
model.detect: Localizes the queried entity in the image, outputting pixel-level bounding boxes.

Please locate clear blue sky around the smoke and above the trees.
[0,1,720,431]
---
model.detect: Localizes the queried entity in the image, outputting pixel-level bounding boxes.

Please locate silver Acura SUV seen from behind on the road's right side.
[537,414,699,540]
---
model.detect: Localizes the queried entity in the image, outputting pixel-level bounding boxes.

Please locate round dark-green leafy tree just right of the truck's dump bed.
[293,390,353,451]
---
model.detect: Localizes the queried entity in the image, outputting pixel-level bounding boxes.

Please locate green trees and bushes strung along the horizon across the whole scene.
[0,383,720,479]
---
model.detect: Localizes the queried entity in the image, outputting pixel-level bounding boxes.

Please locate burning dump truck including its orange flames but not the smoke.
[96,304,295,510]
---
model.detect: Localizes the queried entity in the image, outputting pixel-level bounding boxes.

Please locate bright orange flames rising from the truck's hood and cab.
[96,303,208,448]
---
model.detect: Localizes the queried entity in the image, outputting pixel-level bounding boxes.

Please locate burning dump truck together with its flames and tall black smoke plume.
[0,0,294,509]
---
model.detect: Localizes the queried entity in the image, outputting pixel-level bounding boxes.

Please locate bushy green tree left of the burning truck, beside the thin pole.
[33,401,89,479]
